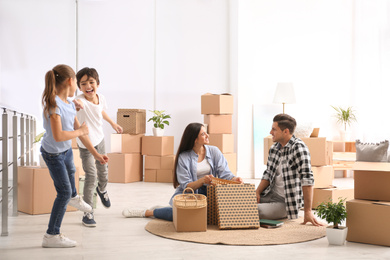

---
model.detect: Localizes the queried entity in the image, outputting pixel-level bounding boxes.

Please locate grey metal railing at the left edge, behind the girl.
[0,107,36,236]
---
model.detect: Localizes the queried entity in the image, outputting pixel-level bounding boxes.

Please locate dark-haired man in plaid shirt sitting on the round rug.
[256,114,323,226]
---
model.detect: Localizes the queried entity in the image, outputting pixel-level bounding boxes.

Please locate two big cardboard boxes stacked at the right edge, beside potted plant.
[347,162,390,246]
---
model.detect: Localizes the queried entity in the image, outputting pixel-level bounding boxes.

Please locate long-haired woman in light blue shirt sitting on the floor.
[122,123,243,221]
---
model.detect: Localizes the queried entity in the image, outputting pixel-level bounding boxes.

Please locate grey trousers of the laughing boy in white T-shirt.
[79,139,108,207]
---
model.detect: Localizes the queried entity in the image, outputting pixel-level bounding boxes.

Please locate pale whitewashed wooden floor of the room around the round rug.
[0,178,390,260]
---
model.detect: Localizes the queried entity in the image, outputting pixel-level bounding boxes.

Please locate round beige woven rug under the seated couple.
[145,218,326,246]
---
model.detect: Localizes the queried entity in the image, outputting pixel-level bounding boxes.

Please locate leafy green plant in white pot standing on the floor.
[316,198,348,245]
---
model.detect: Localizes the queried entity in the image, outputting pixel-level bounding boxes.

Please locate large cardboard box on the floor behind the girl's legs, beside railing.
[18,166,79,215]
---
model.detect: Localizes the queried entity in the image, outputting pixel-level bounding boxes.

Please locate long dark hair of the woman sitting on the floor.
[173,123,203,189]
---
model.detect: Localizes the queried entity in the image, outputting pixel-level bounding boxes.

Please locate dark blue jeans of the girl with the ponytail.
[41,147,77,235]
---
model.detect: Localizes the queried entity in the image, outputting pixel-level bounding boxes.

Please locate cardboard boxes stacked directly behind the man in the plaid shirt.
[264,136,353,209]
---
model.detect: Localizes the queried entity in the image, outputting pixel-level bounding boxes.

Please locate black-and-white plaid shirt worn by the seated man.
[261,136,314,219]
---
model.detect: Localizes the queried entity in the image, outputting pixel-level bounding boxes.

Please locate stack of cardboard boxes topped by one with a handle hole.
[108,109,146,183]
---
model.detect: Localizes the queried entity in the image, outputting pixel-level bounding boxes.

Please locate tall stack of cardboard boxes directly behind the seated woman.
[201,93,237,175]
